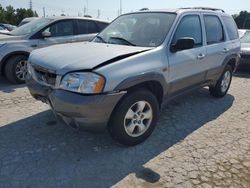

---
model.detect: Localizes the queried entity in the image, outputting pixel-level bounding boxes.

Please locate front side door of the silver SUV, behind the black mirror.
[169,14,206,94]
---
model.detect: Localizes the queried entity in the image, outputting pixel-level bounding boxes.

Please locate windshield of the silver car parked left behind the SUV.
[10,18,52,36]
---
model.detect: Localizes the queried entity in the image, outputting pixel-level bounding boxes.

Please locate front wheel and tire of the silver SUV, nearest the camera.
[108,89,159,146]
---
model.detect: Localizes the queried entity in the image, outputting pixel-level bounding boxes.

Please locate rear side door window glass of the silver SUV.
[204,15,224,44]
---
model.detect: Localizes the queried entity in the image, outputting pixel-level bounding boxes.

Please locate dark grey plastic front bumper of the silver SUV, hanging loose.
[26,78,125,131]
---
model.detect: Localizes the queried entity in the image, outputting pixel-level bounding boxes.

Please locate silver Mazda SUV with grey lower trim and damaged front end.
[27,8,240,145]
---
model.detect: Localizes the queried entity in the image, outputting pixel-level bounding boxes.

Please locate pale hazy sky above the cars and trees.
[0,0,250,21]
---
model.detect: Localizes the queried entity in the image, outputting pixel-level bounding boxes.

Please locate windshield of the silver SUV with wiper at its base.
[93,13,176,47]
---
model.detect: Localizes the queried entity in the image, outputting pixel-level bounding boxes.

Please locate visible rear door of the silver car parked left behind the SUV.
[75,19,99,42]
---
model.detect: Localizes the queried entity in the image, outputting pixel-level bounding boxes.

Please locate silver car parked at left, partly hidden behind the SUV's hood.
[0,17,108,84]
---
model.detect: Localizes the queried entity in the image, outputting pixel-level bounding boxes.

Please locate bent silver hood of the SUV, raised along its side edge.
[29,42,151,75]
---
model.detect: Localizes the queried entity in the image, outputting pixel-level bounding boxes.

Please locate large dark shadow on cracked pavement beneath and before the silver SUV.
[0,89,234,187]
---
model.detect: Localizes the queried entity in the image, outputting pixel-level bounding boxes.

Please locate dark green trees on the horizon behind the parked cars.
[0,4,250,29]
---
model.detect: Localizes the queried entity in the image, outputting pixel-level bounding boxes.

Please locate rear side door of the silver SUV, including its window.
[203,14,230,80]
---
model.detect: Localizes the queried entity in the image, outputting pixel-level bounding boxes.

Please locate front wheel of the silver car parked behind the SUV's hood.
[5,55,28,84]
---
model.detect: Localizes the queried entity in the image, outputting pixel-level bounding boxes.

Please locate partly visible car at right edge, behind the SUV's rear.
[239,30,250,68]
